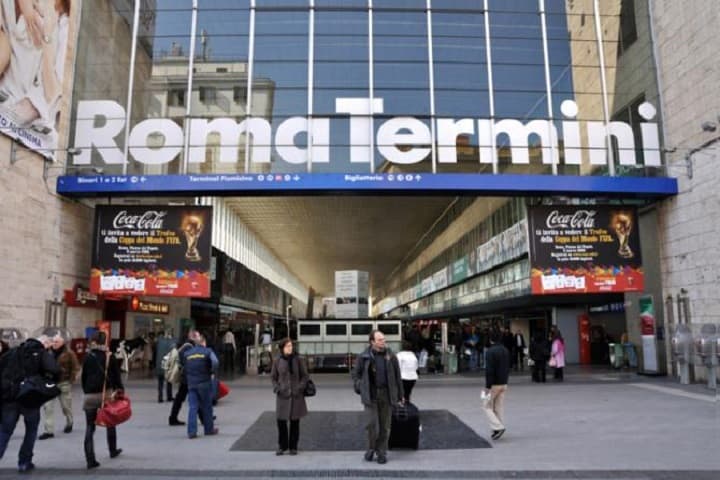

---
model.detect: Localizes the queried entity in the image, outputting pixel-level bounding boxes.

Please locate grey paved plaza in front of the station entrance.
[0,368,720,479]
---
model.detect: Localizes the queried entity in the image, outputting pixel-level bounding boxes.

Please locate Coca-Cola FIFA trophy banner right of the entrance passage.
[528,205,644,294]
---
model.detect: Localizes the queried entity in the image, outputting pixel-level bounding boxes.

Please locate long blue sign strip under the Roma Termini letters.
[57,173,678,198]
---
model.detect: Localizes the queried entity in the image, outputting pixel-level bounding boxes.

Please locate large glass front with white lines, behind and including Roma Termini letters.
[70,0,663,175]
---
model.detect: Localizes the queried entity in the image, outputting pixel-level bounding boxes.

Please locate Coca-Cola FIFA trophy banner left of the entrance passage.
[90,205,212,297]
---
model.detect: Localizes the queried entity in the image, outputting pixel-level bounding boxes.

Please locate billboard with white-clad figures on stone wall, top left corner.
[0,1,70,158]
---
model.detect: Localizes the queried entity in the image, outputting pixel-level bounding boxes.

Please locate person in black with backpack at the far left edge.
[0,335,60,473]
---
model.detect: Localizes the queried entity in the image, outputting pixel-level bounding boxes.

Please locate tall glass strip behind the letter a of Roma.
[251,10,309,173]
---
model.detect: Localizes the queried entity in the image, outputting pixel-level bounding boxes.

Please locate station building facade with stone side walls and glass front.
[0,0,720,376]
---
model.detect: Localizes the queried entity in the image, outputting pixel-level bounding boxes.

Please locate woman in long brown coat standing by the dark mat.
[270,338,310,455]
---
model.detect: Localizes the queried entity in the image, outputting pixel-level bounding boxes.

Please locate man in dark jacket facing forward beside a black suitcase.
[352,330,405,464]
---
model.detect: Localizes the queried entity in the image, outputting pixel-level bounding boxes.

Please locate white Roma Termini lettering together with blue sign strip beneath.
[58,98,677,196]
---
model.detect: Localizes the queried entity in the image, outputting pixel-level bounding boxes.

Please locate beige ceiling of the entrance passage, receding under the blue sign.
[226,196,454,296]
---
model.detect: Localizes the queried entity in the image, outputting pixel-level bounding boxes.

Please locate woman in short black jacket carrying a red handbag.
[81,332,123,469]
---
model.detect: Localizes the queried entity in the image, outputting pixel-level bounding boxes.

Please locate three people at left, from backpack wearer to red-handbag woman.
[0,332,124,473]
